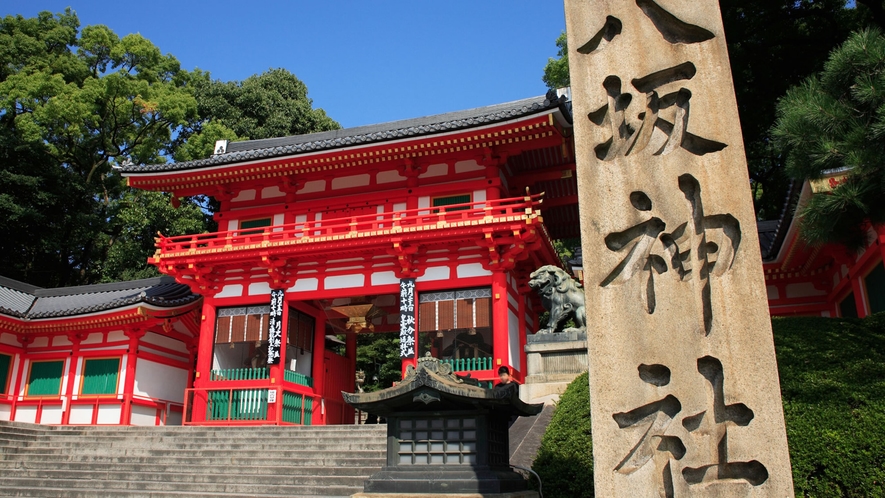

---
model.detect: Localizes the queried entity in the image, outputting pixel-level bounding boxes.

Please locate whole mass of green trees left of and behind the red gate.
[0,9,338,287]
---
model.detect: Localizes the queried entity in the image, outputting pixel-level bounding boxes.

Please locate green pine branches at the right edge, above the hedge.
[774,28,885,248]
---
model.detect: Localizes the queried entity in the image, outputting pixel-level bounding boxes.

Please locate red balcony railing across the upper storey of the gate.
[156,194,543,254]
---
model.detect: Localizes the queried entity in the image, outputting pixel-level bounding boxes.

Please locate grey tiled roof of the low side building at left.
[0,277,200,319]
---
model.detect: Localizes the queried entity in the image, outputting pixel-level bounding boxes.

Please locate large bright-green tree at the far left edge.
[0,9,197,286]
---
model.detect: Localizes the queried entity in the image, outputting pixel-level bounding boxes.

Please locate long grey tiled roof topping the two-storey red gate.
[121,92,571,175]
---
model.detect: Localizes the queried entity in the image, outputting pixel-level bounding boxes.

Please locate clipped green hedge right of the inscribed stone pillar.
[772,315,885,498]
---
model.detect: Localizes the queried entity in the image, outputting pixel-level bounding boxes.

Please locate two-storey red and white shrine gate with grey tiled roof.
[124,95,578,425]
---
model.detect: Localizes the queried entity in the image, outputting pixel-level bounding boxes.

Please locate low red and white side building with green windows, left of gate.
[0,276,202,425]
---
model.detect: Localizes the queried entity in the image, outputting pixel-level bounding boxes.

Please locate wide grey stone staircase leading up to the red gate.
[0,422,386,498]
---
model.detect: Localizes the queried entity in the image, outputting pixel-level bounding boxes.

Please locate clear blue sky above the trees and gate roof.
[0,0,565,127]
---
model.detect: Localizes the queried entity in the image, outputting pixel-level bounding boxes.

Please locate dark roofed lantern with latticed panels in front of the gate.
[342,355,543,497]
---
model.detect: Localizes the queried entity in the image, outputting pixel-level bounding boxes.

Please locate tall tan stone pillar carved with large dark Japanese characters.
[565,0,793,497]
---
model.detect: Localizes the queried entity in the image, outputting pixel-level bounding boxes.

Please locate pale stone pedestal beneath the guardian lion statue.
[519,332,587,402]
